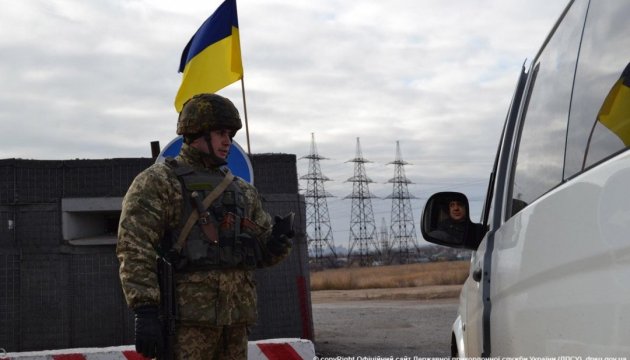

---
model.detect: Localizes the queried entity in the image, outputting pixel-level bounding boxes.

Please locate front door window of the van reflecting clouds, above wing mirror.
[509,1,588,215]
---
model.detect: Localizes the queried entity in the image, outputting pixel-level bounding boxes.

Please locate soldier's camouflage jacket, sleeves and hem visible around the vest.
[116,144,288,326]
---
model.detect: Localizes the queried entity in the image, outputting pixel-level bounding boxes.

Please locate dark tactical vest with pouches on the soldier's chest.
[167,159,262,271]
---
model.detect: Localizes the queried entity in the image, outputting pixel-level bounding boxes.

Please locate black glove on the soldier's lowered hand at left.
[133,305,164,358]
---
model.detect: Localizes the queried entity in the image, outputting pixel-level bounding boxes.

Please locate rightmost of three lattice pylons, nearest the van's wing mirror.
[386,141,419,263]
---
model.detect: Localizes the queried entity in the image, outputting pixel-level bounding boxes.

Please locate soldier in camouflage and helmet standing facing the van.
[116,94,294,359]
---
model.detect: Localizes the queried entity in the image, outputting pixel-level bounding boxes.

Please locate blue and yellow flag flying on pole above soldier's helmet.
[175,0,243,112]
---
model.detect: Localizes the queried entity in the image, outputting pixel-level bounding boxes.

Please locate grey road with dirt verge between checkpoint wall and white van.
[311,285,461,358]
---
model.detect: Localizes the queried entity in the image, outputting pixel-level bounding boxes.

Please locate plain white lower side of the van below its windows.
[491,152,630,356]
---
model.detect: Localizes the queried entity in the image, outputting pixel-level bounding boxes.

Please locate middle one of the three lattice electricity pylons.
[345,138,380,266]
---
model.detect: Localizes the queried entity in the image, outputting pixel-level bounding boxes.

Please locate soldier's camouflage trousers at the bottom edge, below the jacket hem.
[175,324,247,360]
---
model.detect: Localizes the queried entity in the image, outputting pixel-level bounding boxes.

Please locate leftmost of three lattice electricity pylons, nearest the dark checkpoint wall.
[300,133,337,264]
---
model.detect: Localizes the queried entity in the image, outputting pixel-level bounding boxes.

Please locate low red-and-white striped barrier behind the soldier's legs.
[0,339,315,360]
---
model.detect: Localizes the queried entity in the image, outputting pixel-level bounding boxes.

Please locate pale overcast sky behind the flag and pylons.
[0,0,567,250]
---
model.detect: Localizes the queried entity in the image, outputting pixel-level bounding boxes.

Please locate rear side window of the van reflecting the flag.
[564,1,630,179]
